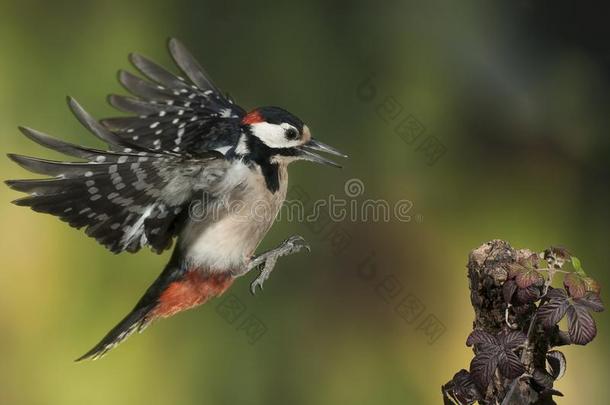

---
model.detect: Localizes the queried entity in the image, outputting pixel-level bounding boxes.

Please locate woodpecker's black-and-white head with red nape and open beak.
[235,107,347,167]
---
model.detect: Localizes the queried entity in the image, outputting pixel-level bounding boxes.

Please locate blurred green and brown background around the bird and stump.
[0,0,610,405]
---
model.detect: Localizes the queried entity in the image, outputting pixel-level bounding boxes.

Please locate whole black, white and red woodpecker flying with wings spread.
[6,39,347,360]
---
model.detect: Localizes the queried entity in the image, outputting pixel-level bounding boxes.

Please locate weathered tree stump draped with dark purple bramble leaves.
[442,240,592,405]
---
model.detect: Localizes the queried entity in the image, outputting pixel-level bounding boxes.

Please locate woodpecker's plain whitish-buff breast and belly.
[180,164,287,272]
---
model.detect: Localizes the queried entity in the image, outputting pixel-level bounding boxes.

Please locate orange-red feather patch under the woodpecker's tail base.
[152,270,234,318]
